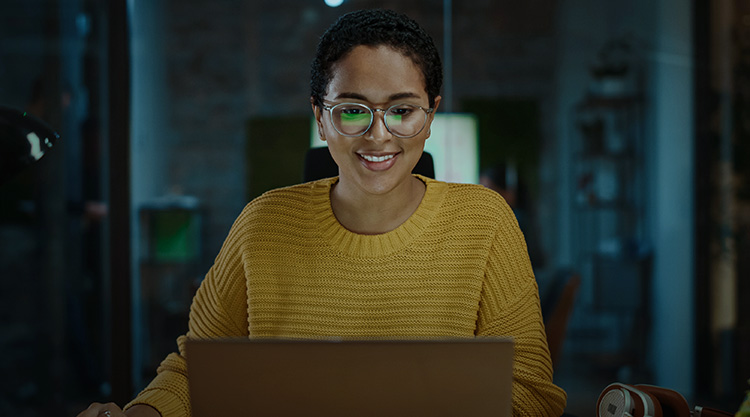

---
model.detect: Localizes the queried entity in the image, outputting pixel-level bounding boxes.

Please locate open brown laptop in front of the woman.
[186,338,513,417]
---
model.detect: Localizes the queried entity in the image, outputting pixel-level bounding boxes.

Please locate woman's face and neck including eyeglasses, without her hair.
[313,45,440,234]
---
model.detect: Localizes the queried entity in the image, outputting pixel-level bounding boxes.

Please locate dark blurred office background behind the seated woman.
[0,0,750,416]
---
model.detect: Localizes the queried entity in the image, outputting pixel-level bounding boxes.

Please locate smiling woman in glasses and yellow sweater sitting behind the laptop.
[79,10,565,417]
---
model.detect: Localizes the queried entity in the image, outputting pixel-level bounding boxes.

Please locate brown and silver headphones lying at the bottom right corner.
[596,382,732,417]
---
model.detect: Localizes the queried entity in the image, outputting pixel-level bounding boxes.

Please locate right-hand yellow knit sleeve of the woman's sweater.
[477,209,567,417]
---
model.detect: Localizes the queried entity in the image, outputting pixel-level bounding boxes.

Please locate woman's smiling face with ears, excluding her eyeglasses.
[313,45,440,195]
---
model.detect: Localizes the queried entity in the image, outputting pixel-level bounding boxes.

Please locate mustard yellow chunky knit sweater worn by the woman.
[128,177,566,417]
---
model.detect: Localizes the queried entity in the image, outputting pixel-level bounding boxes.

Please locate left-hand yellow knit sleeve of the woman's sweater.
[125,211,248,417]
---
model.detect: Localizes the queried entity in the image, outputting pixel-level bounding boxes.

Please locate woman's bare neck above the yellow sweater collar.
[331,177,426,235]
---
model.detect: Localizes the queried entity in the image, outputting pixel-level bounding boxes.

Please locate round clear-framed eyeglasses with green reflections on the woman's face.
[323,103,435,138]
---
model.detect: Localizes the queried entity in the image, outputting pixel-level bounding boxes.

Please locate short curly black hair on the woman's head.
[310,9,443,107]
